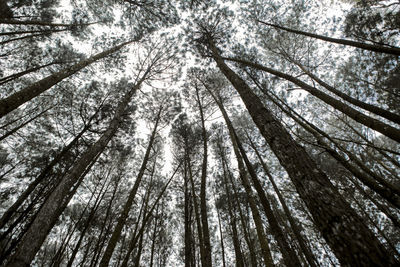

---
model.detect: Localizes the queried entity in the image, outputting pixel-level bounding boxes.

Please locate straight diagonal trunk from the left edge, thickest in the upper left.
[0,39,137,118]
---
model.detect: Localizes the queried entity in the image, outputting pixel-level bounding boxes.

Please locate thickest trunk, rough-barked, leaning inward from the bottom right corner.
[208,39,397,266]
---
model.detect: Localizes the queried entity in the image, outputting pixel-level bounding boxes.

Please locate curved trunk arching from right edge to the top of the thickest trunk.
[220,57,400,143]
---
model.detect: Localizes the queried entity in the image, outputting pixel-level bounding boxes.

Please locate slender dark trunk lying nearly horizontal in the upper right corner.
[257,20,400,55]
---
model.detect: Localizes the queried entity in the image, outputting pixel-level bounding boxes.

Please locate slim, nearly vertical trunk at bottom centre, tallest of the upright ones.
[196,87,212,267]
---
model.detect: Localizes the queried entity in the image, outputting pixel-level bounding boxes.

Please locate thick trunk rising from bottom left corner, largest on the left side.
[7,76,147,267]
